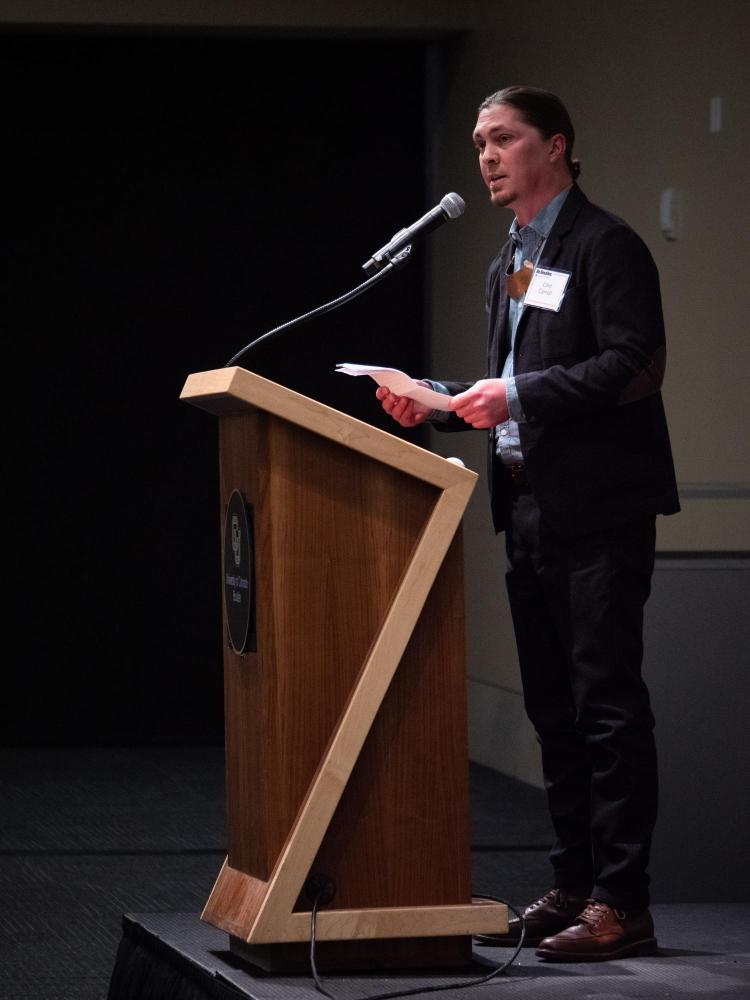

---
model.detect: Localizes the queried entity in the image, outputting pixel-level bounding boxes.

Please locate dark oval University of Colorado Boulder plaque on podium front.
[223,490,255,653]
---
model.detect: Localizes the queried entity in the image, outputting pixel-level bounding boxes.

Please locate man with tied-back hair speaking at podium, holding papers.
[377,87,679,961]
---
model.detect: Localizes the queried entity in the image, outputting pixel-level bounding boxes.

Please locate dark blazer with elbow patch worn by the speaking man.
[435,185,679,535]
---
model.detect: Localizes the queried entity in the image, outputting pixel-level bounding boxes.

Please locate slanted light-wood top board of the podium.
[180,367,478,491]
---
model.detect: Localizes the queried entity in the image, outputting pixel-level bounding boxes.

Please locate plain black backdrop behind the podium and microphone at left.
[13,31,434,744]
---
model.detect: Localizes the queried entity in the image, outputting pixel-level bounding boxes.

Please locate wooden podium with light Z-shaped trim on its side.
[181,368,507,969]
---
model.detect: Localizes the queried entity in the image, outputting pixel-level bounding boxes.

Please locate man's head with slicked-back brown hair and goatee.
[474,86,579,224]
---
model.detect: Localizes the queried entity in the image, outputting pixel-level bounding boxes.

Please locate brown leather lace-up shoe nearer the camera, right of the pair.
[536,899,657,962]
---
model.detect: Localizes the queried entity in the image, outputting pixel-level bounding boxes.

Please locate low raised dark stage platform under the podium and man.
[109,903,750,1000]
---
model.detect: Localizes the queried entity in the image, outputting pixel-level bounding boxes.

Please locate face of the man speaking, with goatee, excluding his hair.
[474,104,564,211]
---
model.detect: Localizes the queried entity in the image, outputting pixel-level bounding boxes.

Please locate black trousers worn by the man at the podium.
[506,492,657,910]
